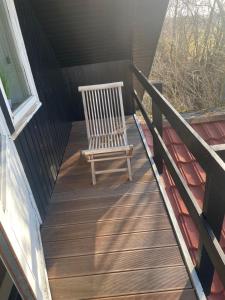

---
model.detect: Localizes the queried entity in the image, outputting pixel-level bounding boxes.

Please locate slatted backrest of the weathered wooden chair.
[78,82,126,140]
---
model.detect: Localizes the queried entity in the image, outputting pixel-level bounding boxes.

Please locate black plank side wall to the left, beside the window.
[15,0,71,217]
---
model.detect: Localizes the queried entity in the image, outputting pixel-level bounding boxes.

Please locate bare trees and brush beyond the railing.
[145,0,225,111]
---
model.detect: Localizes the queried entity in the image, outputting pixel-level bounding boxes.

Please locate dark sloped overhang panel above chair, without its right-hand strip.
[31,0,134,67]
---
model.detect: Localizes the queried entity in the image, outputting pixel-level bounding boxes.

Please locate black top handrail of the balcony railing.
[131,65,225,186]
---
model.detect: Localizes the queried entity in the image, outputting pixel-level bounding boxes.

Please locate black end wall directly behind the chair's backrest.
[63,60,134,121]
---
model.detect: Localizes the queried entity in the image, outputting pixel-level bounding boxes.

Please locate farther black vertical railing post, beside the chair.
[152,82,163,174]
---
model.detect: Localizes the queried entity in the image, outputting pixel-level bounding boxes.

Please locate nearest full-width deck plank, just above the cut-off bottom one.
[50,266,191,300]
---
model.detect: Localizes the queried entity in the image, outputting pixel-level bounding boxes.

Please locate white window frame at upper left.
[0,0,41,137]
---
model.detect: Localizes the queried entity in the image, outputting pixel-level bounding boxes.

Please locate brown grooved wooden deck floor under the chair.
[42,118,196,300]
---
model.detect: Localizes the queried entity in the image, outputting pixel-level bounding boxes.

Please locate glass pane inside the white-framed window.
[0,0,30,111]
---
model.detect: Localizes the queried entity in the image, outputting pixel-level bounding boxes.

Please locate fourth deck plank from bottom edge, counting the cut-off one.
[45,229,177,258]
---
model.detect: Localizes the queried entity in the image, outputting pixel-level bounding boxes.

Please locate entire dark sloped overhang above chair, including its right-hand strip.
[30,0,168,71]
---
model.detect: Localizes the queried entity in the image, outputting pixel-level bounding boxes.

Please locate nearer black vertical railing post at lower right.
[197,172,225,295]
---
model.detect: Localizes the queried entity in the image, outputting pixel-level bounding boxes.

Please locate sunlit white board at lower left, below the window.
[0,97,51,300]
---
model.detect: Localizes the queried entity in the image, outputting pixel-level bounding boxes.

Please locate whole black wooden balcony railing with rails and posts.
[131,65,225,295]
